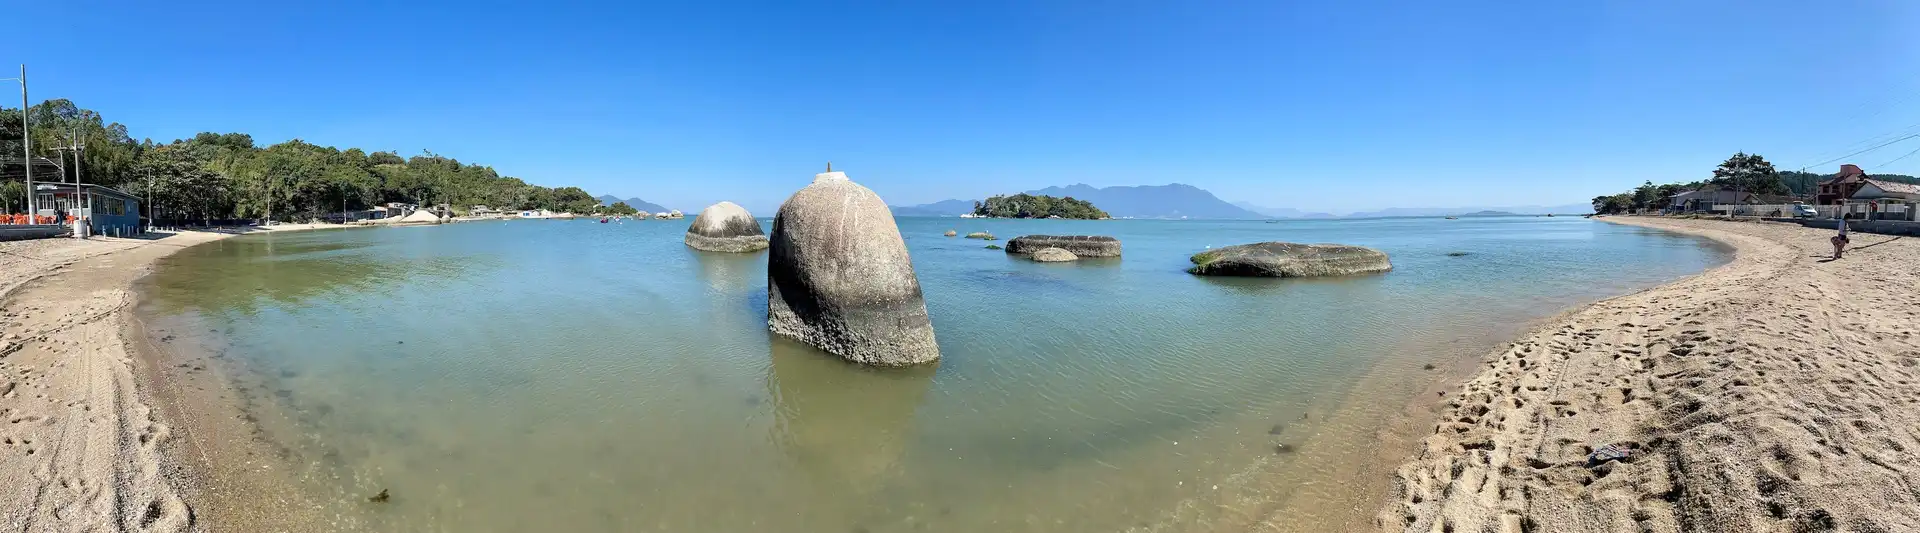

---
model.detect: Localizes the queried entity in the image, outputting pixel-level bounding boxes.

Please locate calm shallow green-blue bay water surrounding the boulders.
[142,219,1726,533]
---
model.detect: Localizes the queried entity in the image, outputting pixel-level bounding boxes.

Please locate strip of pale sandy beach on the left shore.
[0,232,223,531]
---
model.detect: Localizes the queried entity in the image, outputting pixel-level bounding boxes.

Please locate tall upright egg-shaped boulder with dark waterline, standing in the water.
[766,173,941,366]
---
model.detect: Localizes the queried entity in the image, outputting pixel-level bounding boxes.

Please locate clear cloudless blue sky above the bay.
[0,0,1920,215]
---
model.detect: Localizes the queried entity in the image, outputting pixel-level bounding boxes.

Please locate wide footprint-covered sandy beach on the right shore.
[1375,219,1920,533]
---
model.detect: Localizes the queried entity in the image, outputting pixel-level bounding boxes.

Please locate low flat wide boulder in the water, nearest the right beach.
[1187,242,1394,278]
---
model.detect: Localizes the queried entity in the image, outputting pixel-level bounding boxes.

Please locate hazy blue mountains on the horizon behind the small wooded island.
[890,184,1594,219]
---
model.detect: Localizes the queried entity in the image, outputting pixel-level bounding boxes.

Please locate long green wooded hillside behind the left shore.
[0,100,599,220]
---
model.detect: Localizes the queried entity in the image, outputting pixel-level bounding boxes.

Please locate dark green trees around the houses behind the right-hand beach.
[1594,151,1920,215]
